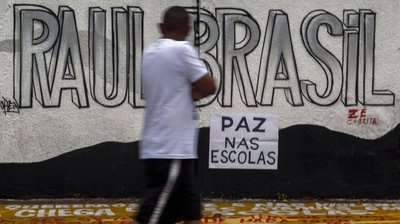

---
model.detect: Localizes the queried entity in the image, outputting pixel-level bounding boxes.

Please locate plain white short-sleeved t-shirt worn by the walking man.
[139,39,208,159]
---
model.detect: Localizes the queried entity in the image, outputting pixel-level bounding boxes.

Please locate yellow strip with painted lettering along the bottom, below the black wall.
[0,199,400,224]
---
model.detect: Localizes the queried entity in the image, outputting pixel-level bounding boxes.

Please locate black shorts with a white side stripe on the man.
[136,159,201,224]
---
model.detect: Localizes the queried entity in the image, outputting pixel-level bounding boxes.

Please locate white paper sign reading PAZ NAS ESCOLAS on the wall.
[208,113,279,170]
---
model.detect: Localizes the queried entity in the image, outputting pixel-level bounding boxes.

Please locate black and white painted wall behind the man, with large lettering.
[0,0,400,198]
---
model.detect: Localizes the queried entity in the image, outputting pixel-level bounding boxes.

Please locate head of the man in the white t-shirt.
[160,6,190,40]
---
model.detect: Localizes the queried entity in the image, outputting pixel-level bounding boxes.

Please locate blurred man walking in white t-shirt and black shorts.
[136,6,216,224]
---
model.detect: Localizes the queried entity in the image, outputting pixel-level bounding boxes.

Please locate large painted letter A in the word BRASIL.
[257,10,303,106]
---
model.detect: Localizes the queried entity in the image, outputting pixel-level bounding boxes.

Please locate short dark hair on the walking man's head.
[163,6,189,31]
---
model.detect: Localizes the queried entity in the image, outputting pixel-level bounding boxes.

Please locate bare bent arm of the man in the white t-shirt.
[192,74,217,101]
